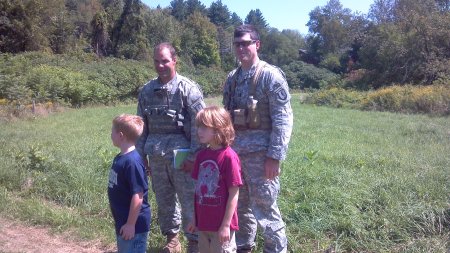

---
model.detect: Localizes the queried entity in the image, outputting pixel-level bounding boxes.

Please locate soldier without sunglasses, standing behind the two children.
[136,43,205,252]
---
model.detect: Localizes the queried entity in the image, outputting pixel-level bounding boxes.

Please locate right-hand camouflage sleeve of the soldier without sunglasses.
[186,83,206,161]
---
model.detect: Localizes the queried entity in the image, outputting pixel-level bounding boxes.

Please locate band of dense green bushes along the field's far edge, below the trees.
[0,52,450,115]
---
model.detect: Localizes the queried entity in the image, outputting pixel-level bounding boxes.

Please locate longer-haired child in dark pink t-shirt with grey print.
[188,106,242,253]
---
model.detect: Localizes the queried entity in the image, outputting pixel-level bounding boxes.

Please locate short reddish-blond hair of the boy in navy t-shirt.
[112,114,144,143]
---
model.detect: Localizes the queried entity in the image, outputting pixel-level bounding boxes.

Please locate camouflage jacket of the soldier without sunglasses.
[136,74,205,160]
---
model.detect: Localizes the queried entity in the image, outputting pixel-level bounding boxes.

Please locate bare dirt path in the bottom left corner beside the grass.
[0,217,115,253]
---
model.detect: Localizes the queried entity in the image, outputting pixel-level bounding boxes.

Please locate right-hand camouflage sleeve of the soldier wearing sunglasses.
[264,68,293,160]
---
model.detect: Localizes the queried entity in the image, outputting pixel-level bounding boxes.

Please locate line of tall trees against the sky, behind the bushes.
[0,0,450,90]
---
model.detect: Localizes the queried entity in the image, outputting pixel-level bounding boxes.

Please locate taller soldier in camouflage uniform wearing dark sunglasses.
[223,25,293,253]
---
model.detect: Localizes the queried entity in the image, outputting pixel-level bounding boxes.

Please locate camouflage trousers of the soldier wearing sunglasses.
[236,152,287,253]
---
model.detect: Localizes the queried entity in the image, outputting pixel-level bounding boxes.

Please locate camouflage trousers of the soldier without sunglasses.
[149,156,197,241]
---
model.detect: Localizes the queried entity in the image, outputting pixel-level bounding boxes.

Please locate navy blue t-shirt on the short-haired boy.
[108,150,151,235]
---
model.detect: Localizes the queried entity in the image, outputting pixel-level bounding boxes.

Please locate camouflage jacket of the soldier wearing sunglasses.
[223,61,293,160]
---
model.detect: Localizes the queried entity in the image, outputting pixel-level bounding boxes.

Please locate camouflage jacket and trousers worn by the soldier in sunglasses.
[223,61,293,252]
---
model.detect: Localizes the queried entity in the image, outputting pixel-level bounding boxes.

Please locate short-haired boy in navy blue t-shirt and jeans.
[108,114,151,253]
